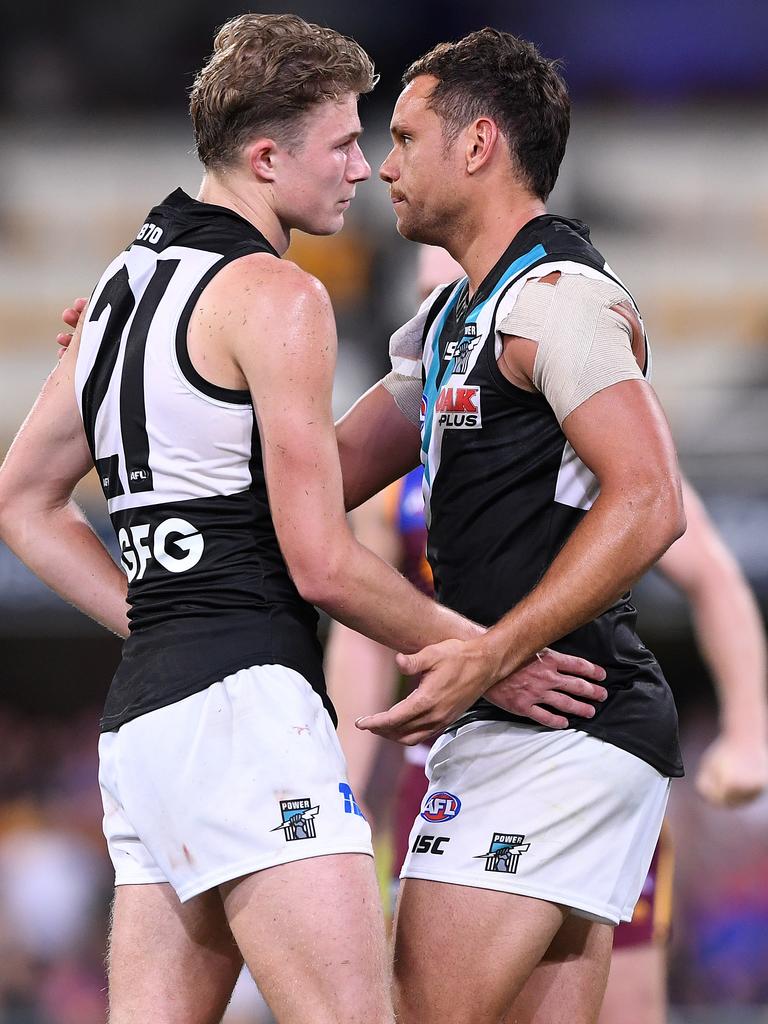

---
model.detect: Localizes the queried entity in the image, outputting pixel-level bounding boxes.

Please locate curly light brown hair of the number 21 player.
[189,14,377,167]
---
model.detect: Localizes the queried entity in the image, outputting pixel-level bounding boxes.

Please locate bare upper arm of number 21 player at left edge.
[0,339,93,510]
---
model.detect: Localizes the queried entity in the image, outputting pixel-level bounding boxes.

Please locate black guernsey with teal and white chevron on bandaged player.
[415,215,683,776]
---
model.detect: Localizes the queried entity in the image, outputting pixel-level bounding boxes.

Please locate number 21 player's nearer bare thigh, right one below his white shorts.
[220,854,393,1024]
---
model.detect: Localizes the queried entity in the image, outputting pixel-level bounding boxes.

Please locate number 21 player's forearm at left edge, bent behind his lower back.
[0,502,128,637]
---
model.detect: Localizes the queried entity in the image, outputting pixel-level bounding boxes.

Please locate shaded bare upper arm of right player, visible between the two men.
[336,383,421,509]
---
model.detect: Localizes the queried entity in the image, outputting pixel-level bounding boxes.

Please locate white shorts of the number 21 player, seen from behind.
[98,665,373,902]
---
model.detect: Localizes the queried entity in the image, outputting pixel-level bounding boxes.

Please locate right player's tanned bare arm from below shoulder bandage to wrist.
[488,372,684,675]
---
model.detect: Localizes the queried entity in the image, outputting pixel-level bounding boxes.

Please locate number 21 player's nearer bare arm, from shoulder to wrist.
[218,256,478,650]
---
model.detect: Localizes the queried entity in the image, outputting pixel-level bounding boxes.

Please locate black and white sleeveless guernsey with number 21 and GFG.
[76,189,335,730]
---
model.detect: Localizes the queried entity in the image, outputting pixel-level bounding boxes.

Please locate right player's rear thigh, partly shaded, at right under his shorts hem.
[503,914,614,1024]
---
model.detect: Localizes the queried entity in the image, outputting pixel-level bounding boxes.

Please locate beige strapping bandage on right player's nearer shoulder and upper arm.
[497,274,644,426]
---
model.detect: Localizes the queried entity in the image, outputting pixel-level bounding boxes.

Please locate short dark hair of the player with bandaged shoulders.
[402,29,570,200]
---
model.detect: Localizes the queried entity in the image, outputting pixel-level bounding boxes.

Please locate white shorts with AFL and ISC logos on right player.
[400,722,670,925]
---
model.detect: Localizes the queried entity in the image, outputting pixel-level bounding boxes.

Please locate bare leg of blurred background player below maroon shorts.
[600,942,667,1024]
